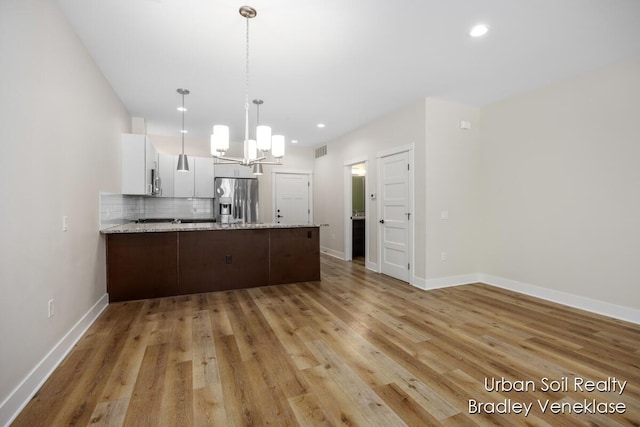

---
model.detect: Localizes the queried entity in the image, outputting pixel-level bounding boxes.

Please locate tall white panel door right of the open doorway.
[380,152,410,282]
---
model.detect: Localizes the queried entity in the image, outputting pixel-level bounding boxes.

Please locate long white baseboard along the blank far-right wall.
[477,274,640,324]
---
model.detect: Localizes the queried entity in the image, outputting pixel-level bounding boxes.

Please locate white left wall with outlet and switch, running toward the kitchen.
[0,0,130,425]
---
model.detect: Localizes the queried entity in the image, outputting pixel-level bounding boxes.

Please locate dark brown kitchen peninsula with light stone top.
[101,222,320,302]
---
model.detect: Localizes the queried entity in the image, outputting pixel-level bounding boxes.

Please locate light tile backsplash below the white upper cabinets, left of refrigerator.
[100,193,213,230]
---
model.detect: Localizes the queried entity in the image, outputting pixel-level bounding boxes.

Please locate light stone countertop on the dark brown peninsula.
[100,222,319,234]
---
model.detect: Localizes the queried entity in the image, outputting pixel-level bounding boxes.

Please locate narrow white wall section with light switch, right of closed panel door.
[424,98,481,284]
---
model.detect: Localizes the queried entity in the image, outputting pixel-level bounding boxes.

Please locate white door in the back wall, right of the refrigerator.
[274,173,311,224]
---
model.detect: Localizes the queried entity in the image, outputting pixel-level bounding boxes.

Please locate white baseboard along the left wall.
[0,294,109,427]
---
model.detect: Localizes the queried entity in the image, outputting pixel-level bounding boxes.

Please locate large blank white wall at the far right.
[478,58,640,309]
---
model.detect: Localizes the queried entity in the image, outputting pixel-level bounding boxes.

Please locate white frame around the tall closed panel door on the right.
[376,142,416,284]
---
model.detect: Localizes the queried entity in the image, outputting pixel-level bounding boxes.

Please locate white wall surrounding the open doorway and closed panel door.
[314,99,426,278]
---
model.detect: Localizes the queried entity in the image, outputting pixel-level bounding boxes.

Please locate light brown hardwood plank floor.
[14,255,640,426]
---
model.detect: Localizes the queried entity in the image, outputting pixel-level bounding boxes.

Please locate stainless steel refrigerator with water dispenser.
[213,178,258,224]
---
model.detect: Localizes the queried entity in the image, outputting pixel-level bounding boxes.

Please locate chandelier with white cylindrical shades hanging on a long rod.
[211,6,285,175]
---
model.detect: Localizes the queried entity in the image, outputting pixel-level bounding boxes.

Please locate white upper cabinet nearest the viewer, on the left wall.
[122,133,158,195]
